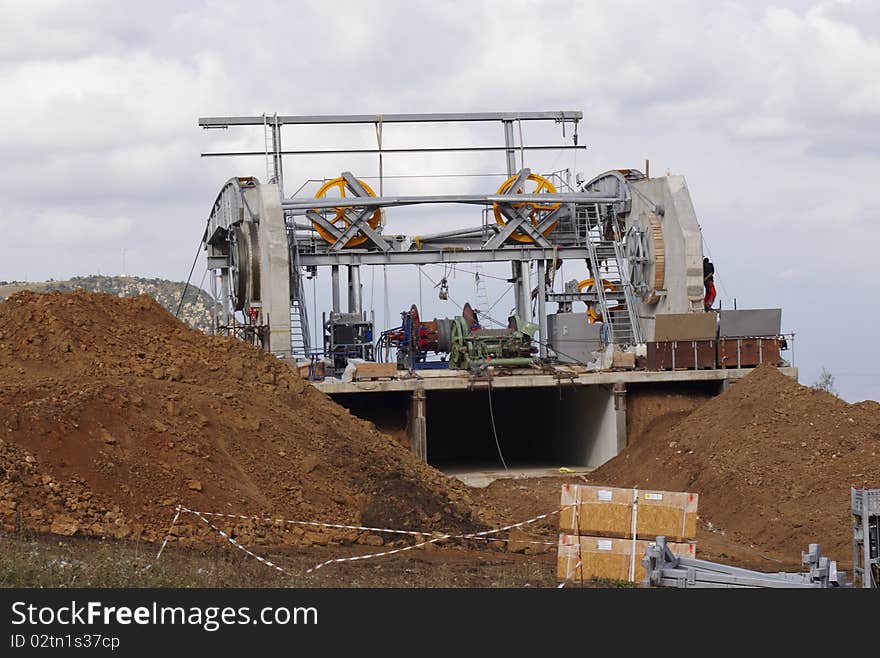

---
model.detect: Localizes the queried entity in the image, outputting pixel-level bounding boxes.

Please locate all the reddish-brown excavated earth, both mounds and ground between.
[0,291,880,570]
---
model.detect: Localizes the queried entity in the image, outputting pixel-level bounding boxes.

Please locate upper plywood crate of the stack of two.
[559,484,699,542]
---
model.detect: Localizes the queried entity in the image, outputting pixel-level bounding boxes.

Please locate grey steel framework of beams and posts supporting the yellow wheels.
[198,111,639,357]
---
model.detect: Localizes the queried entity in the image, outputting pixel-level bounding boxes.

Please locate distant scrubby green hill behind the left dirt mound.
[0,275,212,333]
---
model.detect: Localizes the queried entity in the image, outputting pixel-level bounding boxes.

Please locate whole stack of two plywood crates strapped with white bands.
[557,484,698,582]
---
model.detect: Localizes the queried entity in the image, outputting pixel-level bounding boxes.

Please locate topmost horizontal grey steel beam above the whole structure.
[199,110,584,127]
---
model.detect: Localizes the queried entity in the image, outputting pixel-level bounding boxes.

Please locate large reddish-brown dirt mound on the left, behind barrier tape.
[0,291,482,543]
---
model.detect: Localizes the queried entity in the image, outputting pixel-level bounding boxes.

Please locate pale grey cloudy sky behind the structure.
[0,0,880,400]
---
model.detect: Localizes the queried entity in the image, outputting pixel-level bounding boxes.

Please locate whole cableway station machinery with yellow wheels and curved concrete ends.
[199,111,716,371]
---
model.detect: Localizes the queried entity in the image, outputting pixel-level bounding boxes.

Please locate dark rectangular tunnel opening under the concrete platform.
[334,385,626,474]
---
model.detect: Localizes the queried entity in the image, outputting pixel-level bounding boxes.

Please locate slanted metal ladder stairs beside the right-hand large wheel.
[576,203,641,345]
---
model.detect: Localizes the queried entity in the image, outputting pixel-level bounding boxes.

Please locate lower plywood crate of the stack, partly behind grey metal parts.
[556,534,697,583]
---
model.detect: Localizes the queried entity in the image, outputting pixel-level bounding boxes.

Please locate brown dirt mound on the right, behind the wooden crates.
[590,367,880,562]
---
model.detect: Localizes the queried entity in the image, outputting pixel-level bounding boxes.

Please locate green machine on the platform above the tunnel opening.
[449,315,538,370]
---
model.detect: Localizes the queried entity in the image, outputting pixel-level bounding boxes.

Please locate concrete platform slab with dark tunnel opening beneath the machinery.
[314,367,797,471]
